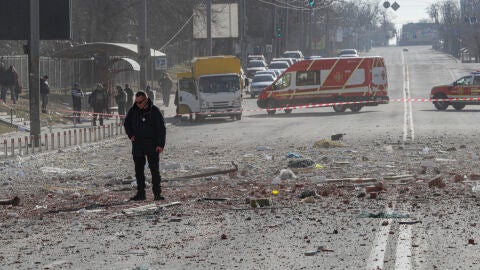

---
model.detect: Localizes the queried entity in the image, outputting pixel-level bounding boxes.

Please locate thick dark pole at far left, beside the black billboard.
[27,0,40,147]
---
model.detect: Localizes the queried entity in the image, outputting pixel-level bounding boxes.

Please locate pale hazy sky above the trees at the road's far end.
[381,0,438,24]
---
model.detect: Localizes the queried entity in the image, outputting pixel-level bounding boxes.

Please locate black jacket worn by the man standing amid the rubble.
[123,99,166,156]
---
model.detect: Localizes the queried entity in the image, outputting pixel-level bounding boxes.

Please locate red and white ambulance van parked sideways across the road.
[257,56,389,114]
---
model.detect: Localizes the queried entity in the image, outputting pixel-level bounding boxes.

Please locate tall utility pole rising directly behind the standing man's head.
[137,0,150,90]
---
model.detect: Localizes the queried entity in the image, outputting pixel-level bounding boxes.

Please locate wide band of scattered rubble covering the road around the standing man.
[0,135,480,269]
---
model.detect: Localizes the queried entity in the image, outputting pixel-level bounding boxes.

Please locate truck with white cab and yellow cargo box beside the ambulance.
[177,56,243,120]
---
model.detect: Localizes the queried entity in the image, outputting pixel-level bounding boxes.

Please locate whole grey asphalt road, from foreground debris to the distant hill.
[0,47,480,270]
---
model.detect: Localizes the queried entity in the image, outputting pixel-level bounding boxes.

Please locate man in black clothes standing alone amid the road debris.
[124,91,166,201]
